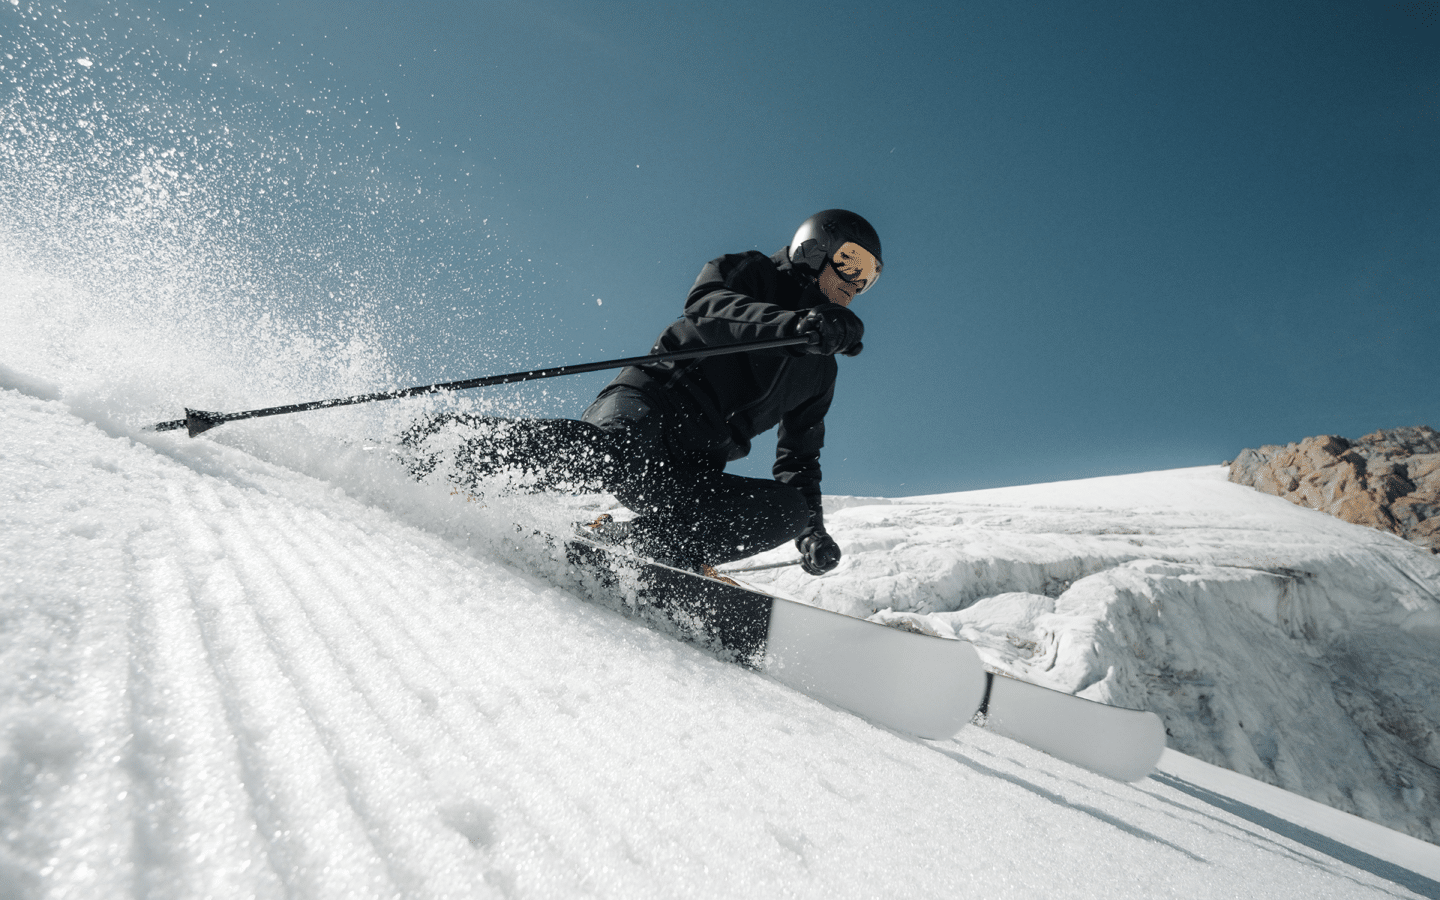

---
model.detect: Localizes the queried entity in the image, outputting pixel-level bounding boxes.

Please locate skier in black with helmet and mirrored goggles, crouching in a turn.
[412,209,883,575]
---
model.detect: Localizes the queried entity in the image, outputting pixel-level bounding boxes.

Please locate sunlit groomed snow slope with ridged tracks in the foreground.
[8,370,1440,899]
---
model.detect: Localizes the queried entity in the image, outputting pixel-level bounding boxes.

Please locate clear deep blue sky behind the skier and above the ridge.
[14,0,1440,495]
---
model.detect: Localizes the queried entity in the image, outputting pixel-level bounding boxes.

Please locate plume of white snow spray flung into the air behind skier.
[0,3,532,440]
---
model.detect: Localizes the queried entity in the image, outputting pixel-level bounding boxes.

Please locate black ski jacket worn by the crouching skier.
[606,248,837,527]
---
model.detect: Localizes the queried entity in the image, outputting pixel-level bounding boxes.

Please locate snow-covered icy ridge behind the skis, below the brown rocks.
[756,467,1440,841]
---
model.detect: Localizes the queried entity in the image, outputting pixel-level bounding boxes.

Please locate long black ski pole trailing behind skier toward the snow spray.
[147,331,819,438]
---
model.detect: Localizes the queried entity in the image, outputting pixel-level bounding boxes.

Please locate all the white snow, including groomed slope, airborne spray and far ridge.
[0,0,1440,900]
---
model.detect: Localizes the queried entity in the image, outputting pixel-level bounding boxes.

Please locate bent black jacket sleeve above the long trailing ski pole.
[685,253,804,346]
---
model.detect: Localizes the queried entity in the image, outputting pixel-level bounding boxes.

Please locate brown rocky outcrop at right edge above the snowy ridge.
[1230,425,1440,553]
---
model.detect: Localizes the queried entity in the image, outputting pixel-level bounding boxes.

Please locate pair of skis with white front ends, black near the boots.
[549,537,1165,782]
